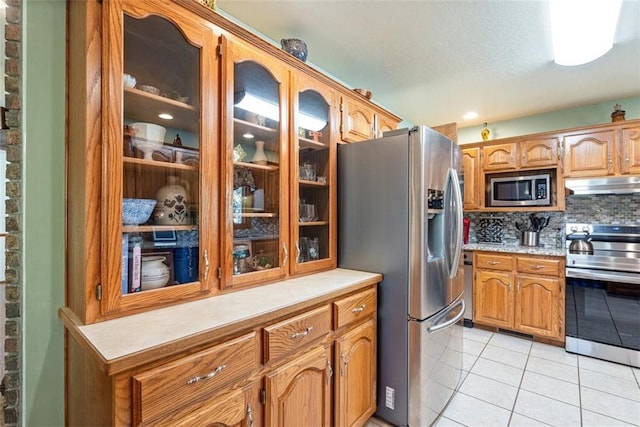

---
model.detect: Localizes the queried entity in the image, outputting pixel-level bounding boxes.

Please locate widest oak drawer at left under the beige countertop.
[132,332,258,425]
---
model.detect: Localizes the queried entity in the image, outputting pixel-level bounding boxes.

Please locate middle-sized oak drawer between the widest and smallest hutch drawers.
[264,305,331,363]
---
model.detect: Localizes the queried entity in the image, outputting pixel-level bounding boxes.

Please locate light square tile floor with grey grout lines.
[366,328,640,427]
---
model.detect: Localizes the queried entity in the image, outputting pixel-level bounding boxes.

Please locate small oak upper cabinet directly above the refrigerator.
[340,95,399,142]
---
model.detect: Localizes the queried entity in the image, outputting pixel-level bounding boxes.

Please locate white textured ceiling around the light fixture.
[217,0,640,127]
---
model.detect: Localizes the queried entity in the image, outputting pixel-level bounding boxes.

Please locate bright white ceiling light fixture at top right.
[549,0,622,66]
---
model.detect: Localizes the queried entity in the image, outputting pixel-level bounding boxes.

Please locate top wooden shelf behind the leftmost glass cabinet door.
[124,88,200,133]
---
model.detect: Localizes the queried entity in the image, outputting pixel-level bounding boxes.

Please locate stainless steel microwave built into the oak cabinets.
[489,174,551,207]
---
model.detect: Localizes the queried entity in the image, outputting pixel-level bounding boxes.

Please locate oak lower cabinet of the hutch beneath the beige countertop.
[62,283,377,427]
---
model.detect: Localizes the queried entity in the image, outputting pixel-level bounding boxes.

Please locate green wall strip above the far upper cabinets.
[458,96,640,144]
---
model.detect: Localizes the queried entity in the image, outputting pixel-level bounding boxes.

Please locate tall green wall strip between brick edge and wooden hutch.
[22,0,66,426]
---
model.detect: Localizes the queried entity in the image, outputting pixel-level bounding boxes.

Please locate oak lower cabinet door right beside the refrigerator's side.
[335,319,376,427]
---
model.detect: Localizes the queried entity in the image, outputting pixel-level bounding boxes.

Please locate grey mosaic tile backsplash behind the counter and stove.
[464,194,640,247]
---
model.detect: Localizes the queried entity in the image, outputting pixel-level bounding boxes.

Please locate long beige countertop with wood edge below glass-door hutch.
[60,268,382,373]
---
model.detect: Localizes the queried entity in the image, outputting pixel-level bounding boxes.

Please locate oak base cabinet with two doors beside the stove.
[473,252,564,341]
